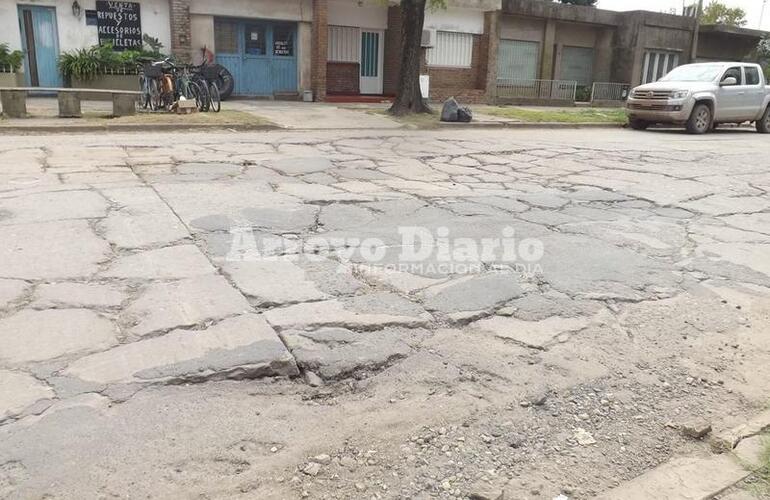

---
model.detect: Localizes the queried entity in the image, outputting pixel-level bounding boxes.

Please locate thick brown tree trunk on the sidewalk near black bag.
[390,0,431,115]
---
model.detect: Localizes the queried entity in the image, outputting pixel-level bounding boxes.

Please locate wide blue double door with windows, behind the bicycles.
[214,19,297,95]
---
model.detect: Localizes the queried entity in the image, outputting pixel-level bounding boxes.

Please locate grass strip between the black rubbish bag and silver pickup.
[478,106,626,123]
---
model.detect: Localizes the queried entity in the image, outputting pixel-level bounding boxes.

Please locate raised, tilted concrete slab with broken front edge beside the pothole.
[64,314,299,385]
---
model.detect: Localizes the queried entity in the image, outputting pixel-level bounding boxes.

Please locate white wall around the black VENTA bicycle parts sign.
[0,0,171,52]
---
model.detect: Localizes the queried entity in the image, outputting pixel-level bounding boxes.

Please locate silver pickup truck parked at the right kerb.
[626,62,770,134]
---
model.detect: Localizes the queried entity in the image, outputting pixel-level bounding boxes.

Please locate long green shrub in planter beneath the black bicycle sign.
[59,40,165,81]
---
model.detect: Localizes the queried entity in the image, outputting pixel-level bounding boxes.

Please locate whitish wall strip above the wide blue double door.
[190,0,313,21]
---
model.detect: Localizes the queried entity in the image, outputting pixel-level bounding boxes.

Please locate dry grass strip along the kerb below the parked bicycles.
[83,110,273,127]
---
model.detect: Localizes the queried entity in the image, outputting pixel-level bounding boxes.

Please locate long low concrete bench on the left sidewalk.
[0,87,142,118]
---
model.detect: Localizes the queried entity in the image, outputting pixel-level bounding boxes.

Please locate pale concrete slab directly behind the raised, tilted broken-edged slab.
[120,275,251,336]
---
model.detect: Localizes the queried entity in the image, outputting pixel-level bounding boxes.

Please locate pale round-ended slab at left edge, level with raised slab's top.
[0,309,117,366]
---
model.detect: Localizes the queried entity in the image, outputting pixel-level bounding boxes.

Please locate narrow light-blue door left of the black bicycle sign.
[19,5,61,87]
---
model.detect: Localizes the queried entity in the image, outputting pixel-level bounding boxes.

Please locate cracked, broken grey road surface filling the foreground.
[0,129,770,499]
